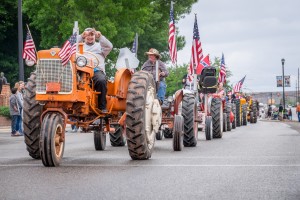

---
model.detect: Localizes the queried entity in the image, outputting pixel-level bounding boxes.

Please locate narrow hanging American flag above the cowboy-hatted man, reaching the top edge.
[169,2,177,64]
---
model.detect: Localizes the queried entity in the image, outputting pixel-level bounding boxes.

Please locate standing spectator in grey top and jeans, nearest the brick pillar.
[9,88,21,136]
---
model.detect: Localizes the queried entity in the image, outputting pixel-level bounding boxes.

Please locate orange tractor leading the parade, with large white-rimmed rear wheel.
[23,41,161,166]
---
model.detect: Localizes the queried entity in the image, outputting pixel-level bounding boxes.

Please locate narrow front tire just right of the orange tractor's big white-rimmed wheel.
[173,115,184,151]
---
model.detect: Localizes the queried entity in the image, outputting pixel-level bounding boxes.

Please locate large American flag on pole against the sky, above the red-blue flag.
[188,15,203,80]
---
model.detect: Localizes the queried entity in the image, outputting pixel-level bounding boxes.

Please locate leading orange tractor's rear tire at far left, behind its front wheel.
[23,72,43,159]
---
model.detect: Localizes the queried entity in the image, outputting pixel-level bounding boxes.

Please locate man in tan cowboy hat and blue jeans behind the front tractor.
[142,48,169,104]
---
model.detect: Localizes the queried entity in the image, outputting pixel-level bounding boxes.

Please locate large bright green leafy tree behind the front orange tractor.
[23,0,197,77]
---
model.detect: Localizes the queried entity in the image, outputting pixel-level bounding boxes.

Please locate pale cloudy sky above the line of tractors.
[175,0,300,92]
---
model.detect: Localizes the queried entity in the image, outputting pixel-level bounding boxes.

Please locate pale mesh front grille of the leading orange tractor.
[36,59,73,94]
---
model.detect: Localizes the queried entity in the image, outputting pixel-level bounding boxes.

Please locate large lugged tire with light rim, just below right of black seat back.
[210,98,223,138]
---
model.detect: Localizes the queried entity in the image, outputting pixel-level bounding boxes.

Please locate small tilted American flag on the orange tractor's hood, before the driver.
[58,33,77,66]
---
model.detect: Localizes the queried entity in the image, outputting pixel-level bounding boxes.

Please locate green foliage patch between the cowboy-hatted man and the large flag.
[166,64,187,96]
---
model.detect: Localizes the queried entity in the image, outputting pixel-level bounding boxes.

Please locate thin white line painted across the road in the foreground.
[0,164,300,167]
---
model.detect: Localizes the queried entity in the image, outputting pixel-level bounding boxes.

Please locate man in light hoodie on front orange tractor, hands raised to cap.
[78,28,113,113]
